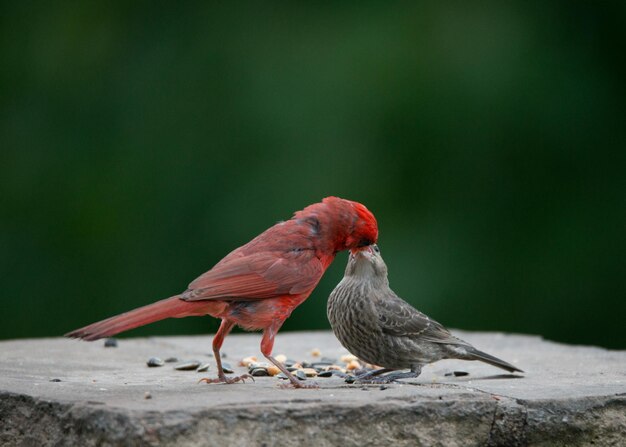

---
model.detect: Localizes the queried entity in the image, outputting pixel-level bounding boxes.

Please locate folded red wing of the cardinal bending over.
[181,250,325,301]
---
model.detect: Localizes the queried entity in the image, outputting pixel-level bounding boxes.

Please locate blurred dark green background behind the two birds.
[0,1,626,348]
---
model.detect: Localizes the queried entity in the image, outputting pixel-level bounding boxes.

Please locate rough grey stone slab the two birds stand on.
[0,332,626,446]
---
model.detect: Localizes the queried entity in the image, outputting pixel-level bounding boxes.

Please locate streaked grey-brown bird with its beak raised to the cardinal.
[327,245,523,382]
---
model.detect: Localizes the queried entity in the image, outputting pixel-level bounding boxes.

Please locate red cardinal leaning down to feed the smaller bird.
[66,197,378,388]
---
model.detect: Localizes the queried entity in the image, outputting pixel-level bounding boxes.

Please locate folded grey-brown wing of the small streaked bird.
[376,290,466,345]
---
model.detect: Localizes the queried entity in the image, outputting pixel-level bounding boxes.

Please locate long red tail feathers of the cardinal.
[65,295,222,341]
